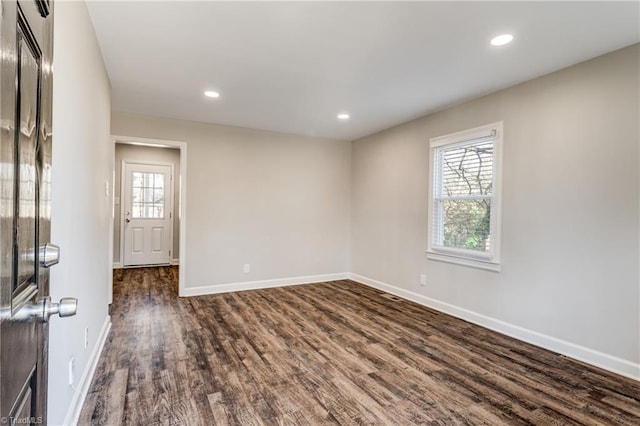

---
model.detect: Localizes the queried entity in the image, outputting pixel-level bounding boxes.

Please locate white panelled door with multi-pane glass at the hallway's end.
[121,161,173,266]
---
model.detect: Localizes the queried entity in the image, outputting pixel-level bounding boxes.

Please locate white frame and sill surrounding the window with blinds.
[427,121,503,272]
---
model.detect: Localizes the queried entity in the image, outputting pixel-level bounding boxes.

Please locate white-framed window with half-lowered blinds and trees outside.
[427,122,502,271]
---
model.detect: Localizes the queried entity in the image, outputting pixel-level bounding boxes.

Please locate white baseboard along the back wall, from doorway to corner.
[180,272,349,297]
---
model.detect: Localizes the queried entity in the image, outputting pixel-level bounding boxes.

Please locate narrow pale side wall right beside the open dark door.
[48,2,113,425]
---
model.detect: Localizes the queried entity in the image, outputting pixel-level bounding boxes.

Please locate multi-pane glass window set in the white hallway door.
[131,172,164,219]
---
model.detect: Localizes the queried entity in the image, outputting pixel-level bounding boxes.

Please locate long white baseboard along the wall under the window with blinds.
[349,273,640,380]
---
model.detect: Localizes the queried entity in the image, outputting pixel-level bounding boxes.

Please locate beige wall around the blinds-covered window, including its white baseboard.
[351,45,640,378]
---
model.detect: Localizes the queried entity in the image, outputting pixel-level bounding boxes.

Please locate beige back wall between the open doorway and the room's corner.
[111,112,350,294]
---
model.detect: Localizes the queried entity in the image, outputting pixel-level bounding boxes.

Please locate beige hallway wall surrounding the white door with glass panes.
[113,143,180,264]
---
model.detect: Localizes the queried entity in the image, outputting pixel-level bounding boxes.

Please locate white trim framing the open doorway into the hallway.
[109,135,187,303]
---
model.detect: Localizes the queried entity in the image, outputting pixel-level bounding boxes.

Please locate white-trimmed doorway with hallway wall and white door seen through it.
[109,136,187,303]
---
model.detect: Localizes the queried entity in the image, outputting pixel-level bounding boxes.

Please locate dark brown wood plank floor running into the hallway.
[80,267,640,426]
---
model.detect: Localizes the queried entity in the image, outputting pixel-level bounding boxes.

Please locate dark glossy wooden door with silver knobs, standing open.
[0,0,75,424]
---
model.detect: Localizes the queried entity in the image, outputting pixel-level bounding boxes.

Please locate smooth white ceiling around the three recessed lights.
[89,1,640,140]
